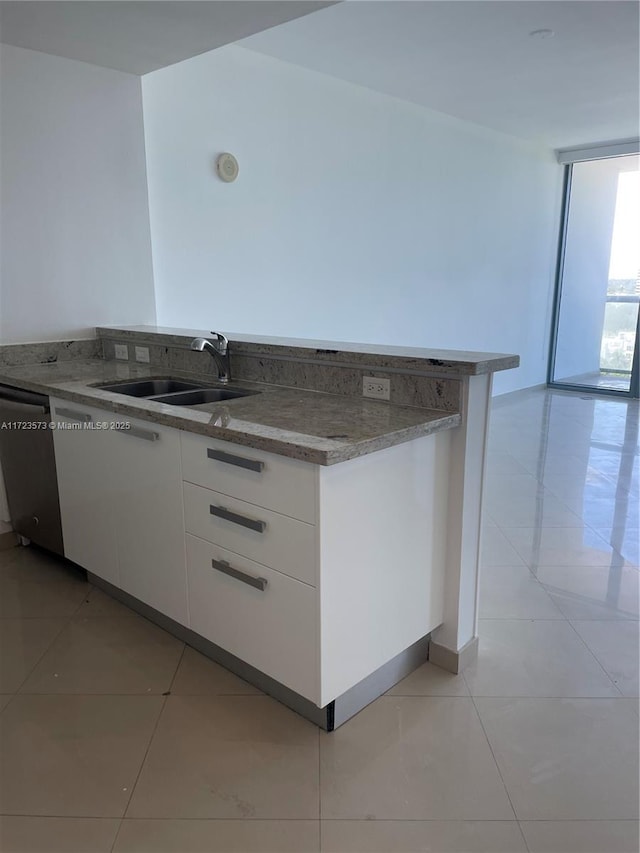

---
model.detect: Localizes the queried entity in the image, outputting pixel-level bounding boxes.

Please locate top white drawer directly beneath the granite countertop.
[182,433,317,524]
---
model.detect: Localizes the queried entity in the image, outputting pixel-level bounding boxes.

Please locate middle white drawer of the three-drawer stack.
[184,483,316,586]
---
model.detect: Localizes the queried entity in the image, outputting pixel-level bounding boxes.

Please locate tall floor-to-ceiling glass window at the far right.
[549,149,640,397]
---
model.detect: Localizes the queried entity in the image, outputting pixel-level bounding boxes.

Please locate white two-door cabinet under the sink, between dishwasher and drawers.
[52,399,189,625]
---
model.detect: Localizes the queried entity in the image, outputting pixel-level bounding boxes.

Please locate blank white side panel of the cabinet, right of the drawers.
[319,431,453,706]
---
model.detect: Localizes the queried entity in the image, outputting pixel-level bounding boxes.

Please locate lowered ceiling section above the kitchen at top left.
[0,0,338,74]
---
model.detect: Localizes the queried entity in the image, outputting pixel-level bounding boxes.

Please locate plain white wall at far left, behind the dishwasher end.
[0,45,155,343]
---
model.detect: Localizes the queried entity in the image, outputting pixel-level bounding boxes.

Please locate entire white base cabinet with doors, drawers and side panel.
[52,400,450,708]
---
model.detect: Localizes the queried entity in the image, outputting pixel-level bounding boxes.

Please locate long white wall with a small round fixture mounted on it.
[142,46,561,393]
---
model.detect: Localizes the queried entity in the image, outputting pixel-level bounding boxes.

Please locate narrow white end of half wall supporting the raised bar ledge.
[429,373,493,672]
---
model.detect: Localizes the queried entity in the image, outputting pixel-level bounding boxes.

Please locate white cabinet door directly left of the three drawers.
[110,417,188,625]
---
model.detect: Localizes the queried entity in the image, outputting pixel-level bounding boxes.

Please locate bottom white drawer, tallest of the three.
[187,535,317,702]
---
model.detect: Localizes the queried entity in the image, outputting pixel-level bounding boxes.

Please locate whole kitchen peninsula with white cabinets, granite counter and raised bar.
[0,327,518,730]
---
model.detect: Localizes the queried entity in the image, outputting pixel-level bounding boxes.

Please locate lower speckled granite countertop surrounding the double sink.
[0,359,461,465]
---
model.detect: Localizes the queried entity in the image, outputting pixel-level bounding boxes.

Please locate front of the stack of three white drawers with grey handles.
[181,433,318,702]
